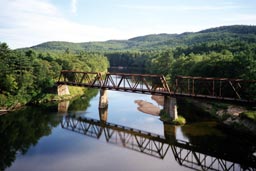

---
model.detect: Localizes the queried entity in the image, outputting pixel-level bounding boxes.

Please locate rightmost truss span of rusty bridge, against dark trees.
[174,76,256,102]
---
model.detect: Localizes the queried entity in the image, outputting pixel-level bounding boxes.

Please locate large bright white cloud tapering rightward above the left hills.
[0,0,127,48]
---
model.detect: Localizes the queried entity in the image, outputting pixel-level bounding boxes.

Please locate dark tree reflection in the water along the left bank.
[0,107,59,170]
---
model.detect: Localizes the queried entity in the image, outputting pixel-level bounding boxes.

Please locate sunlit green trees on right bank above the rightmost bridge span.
[155,42,256,79]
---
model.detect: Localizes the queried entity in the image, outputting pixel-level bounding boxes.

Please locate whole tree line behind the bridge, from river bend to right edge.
[105,41,256,80]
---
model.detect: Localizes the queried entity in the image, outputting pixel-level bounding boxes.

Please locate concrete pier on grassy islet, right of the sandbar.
[164,96,178,120]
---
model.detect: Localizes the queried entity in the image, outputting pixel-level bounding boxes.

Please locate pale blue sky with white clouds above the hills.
[0,0,256,49]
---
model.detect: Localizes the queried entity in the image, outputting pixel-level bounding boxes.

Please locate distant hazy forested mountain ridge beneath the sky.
[27,25,256,53]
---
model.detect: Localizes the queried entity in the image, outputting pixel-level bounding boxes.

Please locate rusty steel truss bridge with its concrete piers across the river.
[57,70,256,119]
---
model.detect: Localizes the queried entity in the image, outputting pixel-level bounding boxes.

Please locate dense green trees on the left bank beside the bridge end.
[0,43,108,108]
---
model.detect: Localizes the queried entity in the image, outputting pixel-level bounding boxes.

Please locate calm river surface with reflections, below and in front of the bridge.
[0,91,256,171]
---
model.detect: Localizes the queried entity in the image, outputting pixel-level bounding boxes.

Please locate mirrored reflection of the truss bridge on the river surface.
[61,110,256,171]
